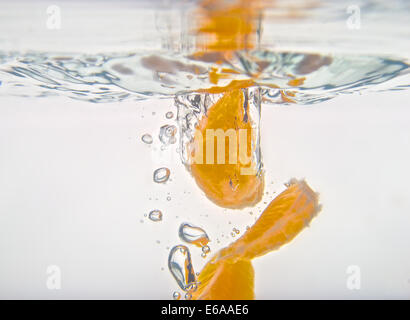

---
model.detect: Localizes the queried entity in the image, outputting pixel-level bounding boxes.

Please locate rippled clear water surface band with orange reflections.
[0,50,409,104]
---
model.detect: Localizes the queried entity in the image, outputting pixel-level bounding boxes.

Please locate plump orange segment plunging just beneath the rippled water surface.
[190,89,264,208]
